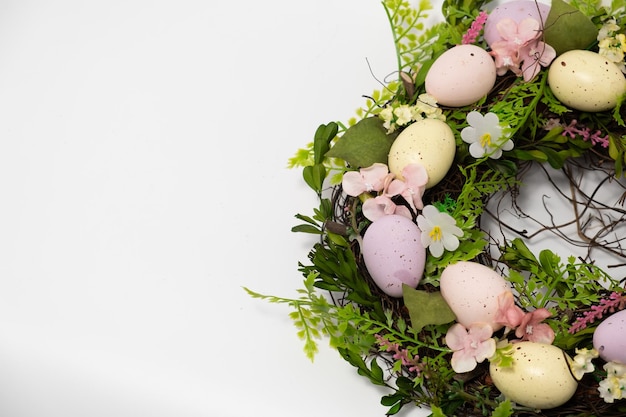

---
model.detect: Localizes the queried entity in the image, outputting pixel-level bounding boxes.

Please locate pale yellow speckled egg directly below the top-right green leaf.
[548,49,626,112]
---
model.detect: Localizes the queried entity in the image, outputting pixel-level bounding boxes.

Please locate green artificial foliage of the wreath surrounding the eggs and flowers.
[246,0,626,417]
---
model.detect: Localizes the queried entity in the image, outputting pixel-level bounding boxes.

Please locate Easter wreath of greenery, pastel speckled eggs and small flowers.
[246,0,626,417]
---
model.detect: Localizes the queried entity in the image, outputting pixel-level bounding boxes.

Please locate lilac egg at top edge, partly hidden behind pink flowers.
[483,0,550,45]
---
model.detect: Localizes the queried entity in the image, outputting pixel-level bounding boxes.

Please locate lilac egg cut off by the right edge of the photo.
[593,310,626,364]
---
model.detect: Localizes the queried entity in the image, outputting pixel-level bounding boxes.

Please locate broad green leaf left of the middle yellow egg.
[326,116,396,168]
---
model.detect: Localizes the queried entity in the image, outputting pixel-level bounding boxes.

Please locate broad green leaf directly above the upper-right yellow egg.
[544,0,598,56]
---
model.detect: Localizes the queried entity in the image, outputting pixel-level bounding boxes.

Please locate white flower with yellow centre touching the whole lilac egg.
[417,205,463,258]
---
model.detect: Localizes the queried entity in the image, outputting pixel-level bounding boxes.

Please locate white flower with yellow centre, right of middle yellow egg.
[461,111,513,159]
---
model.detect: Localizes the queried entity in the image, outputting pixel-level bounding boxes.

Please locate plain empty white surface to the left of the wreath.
[0,0,426,417]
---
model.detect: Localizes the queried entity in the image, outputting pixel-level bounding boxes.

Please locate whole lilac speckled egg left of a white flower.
[361,214,426,297]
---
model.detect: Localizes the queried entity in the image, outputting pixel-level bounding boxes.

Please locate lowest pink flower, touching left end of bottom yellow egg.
[446,323,496,373]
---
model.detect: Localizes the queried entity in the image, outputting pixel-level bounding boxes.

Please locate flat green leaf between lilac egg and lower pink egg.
[402,285,456,332]
